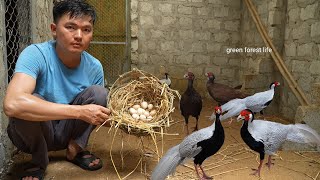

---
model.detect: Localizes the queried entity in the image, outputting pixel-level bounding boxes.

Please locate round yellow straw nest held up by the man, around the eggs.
[108,69,180,137]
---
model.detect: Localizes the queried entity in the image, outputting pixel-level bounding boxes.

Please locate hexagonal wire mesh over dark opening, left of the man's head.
[5,0,31,81]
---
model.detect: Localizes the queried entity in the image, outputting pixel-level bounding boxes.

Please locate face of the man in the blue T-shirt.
[51,14,93,53]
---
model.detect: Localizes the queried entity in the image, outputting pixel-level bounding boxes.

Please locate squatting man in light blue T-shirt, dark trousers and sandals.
[4,0,110,179]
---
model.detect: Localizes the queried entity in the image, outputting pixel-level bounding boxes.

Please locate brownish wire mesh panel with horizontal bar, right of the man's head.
[87,0,126,86]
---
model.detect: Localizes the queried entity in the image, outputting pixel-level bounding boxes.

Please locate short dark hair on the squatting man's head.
[53,0,97,24]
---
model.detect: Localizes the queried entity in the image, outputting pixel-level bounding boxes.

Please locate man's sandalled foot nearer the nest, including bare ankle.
[66,140,102,171]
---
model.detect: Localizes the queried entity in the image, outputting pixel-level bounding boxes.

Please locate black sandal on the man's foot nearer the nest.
[67,151,102,171]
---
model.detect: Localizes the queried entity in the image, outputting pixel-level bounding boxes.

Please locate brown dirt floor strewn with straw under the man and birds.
[3,100,320,180]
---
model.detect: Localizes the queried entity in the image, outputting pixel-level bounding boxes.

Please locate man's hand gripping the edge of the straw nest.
[79,104,110,125]
